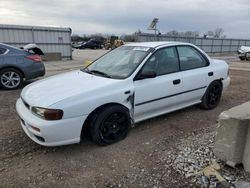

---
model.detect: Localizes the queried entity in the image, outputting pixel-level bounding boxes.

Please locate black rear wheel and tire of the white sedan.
[200,81,222,110]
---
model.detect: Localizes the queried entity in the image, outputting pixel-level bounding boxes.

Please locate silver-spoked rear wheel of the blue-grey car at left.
[0,68,23,90]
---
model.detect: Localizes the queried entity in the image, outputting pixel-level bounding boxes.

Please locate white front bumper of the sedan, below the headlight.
[16,98,87,146]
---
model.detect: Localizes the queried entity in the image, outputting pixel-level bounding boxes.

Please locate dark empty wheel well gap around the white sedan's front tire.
[81,103,129,138]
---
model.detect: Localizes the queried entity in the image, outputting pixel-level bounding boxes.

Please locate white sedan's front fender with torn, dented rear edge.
[49,83,134,118]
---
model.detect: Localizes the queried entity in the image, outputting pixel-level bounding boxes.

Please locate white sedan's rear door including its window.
[177,45,213,105]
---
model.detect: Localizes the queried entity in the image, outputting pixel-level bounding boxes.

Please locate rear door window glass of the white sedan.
[177,46,207,70]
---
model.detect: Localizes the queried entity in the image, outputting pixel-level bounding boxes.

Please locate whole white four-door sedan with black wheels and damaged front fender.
[16,42,230,146]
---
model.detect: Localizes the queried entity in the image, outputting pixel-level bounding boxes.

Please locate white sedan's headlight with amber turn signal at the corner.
[31,107,63,120]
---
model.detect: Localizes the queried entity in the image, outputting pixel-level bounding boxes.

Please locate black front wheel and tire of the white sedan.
[90,105,131,146]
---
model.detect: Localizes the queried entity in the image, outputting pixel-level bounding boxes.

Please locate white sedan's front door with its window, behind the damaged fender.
[134,47,183,122]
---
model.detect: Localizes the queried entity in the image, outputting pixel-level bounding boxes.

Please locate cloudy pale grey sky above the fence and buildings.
[0,0,250,39]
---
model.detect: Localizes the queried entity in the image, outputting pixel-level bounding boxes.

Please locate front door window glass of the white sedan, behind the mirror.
[143,47,180,76]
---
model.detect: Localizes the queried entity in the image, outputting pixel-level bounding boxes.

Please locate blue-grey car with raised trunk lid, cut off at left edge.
[0,43,45,90]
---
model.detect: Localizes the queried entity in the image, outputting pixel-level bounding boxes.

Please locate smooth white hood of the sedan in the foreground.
[21,70,120,108]
